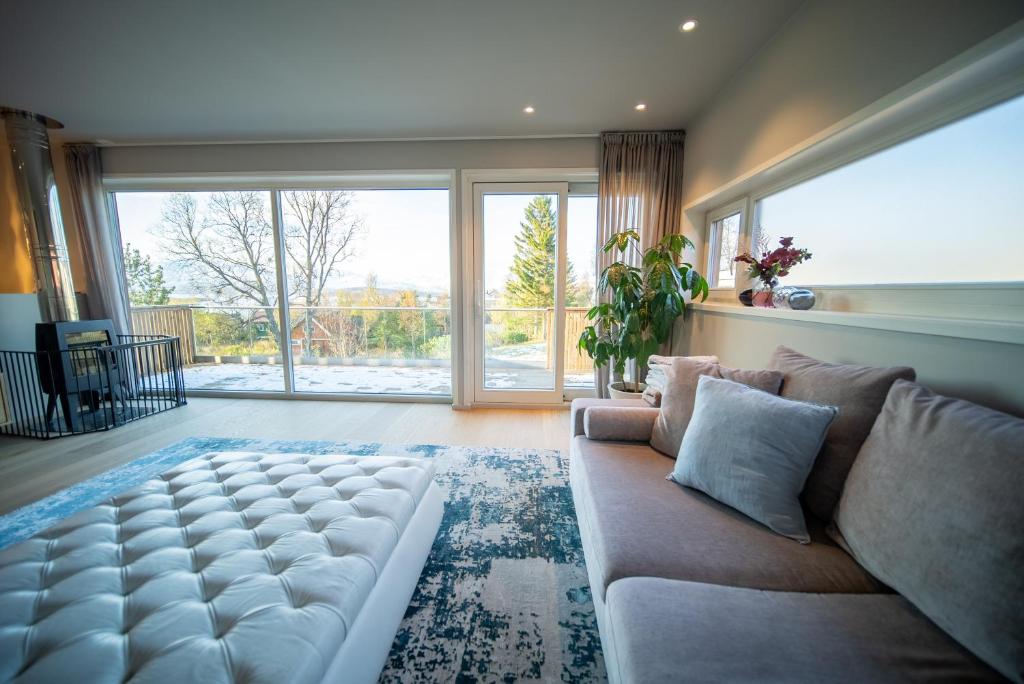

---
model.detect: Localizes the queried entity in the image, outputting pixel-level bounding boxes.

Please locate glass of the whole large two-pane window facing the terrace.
[114,187,452,395]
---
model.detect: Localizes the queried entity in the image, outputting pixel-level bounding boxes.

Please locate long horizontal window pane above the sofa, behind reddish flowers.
[753,92,1024,286]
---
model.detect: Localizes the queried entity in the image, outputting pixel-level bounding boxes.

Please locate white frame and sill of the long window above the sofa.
[684,28,1024,337]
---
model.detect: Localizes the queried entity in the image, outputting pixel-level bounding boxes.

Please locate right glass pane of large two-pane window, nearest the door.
[281,189,452,395]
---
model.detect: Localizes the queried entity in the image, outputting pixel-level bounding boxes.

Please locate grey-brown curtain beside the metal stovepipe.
[63,144,131,335]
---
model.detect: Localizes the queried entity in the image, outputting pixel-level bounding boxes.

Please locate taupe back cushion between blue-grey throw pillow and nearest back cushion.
[768,346,914,521]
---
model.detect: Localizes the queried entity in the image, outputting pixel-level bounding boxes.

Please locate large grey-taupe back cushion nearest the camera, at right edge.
[836,381,1024,682]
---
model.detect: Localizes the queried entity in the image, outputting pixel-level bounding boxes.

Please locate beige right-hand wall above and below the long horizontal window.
[674,0,1024,415]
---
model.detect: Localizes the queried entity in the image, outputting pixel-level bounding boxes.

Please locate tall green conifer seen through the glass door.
[505,195,580,308]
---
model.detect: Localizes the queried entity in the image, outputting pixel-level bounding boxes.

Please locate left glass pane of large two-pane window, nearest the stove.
[114,189,285,392]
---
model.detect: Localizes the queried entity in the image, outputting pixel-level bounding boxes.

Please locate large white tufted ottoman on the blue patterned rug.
[0,452,442,684]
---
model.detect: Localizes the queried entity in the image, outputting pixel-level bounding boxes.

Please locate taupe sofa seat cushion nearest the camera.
[605,578,1004,684]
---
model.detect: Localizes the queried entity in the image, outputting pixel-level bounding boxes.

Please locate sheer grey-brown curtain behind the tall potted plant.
[594,131,685,397]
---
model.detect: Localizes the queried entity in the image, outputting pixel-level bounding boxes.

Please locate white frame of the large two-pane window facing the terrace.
[102,169,463,405]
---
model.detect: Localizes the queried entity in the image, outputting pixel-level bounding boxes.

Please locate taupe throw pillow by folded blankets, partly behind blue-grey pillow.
[650,356,782,459]
